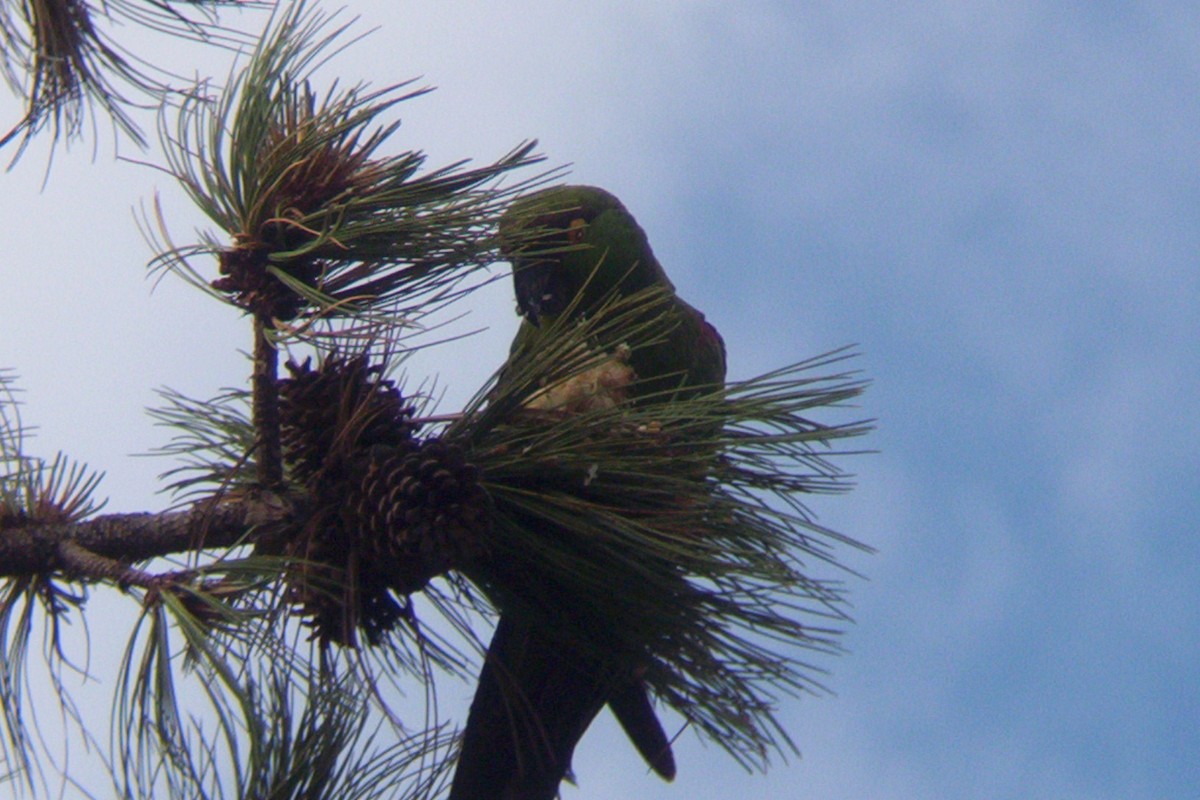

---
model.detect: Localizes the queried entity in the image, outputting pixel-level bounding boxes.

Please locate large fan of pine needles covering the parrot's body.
[448,291,869,768]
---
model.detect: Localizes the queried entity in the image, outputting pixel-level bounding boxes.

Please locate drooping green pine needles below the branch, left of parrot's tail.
[113,578,452,800]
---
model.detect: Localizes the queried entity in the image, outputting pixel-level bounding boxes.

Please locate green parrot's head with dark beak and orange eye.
[499,186,673,325]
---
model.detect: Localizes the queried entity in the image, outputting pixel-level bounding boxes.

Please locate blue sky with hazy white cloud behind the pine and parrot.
[0,0,1200,800]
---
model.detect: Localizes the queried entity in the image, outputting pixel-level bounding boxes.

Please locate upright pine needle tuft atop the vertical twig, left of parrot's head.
[147,2,549,333]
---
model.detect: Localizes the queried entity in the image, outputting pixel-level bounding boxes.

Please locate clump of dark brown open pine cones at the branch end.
[280,355,491,646]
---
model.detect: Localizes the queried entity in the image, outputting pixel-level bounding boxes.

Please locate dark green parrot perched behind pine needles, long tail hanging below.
[450,186,725,800]
